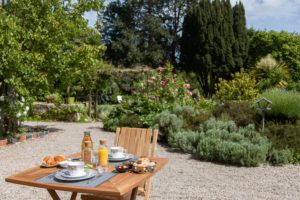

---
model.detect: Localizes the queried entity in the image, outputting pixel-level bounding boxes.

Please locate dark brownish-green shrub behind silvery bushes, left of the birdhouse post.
[213,101,255,126]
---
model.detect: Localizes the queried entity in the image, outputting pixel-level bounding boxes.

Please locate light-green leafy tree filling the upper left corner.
[0,0,105,136]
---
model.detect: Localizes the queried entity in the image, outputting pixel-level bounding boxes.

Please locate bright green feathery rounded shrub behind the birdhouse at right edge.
[261,88,300,122]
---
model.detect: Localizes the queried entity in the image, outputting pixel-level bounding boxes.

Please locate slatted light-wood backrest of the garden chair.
[114,127,158,157]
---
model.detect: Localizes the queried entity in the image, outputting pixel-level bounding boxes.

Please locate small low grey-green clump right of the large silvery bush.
[268,149,293,165]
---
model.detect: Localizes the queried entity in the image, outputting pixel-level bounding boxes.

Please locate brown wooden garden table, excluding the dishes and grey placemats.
[5,154,168,200]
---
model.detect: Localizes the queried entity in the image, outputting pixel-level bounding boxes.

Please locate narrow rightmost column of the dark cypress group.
[233,2,249,68]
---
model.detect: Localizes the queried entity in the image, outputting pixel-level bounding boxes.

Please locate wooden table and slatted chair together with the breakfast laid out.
[5,128,168,200]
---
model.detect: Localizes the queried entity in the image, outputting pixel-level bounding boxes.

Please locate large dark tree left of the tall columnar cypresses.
[99,0,197,67]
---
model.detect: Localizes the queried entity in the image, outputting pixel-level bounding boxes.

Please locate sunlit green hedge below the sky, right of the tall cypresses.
[249,30,300,82]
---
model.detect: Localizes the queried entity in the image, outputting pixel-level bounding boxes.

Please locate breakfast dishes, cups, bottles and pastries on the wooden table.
[41,132,156,182]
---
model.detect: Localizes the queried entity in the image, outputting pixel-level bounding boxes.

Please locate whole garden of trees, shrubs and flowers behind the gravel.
[0,0,300,170]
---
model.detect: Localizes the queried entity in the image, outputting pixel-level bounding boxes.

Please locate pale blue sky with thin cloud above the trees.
[85,0,300,33]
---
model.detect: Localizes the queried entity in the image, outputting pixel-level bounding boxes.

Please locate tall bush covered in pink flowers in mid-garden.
[136,63,193,105]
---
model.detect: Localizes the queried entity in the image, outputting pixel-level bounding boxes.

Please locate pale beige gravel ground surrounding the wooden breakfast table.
[0,122,300,200]
